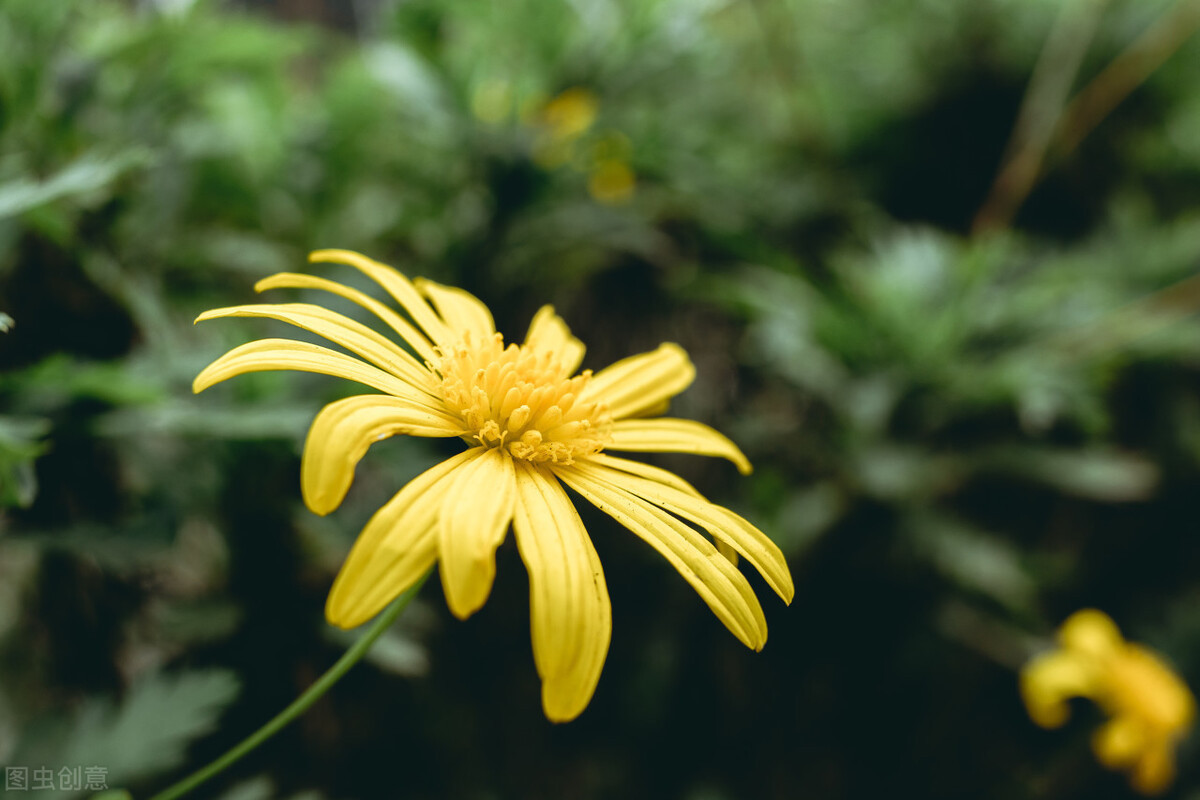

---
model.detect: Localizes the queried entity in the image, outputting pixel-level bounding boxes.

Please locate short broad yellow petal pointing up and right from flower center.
[581,343,696,420]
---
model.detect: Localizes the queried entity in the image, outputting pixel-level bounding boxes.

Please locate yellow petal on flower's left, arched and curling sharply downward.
[300,395,463,515]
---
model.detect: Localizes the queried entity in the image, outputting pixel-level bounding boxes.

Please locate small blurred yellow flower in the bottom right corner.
[1021,609,1195,794]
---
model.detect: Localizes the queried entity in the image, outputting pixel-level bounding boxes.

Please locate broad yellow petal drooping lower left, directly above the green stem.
[325,450,475,628]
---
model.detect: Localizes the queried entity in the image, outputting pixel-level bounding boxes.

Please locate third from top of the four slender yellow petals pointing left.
[196,302,436,395]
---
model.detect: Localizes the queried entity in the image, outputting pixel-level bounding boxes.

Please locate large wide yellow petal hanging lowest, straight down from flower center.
[512,461,612,722]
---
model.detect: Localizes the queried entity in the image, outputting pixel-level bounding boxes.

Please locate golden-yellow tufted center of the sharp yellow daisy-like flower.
[431,333,612,464]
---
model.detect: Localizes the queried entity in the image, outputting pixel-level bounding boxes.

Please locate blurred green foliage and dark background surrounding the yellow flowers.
[0,0,1200,800]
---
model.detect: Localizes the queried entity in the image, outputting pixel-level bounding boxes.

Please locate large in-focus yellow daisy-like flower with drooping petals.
[193,249,793,721]
